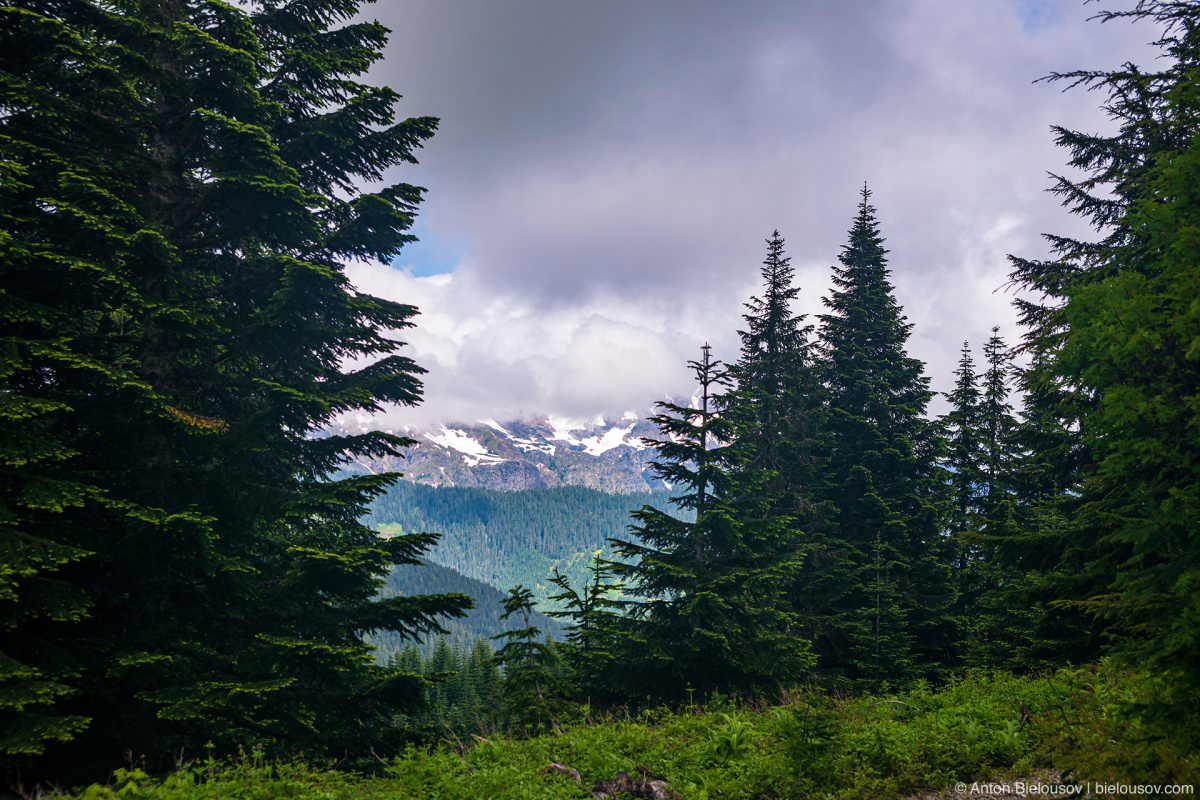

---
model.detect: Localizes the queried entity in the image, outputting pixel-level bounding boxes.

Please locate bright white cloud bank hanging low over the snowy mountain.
[347,264,733,427]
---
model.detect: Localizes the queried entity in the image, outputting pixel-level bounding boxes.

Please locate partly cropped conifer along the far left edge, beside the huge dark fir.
[0,5,144,771]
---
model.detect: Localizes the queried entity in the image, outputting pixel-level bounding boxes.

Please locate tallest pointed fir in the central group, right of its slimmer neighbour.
[820,186,959,679]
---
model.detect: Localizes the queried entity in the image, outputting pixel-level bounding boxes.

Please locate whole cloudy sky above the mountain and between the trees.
[350,0,1157,431]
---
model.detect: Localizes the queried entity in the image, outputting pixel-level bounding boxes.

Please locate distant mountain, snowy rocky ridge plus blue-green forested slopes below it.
[329,414,670,623]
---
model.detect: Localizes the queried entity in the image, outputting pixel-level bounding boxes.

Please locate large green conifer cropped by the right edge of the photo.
[1014,0,1200,744]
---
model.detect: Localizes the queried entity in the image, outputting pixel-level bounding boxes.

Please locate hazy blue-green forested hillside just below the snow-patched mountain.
[366,482,686,608]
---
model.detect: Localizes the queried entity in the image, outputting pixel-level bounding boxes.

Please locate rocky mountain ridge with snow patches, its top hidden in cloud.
[332,414,664,493]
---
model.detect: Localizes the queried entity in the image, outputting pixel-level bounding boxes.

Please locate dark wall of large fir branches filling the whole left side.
[0,0,469,780]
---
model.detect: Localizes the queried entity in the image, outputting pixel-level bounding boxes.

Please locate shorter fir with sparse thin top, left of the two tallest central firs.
[608,344,811,699]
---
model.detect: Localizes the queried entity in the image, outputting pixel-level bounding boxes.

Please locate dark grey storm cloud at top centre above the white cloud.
[377,1,898,300]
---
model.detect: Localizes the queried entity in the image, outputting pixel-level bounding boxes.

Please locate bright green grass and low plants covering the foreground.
[46,668,1200,800]
